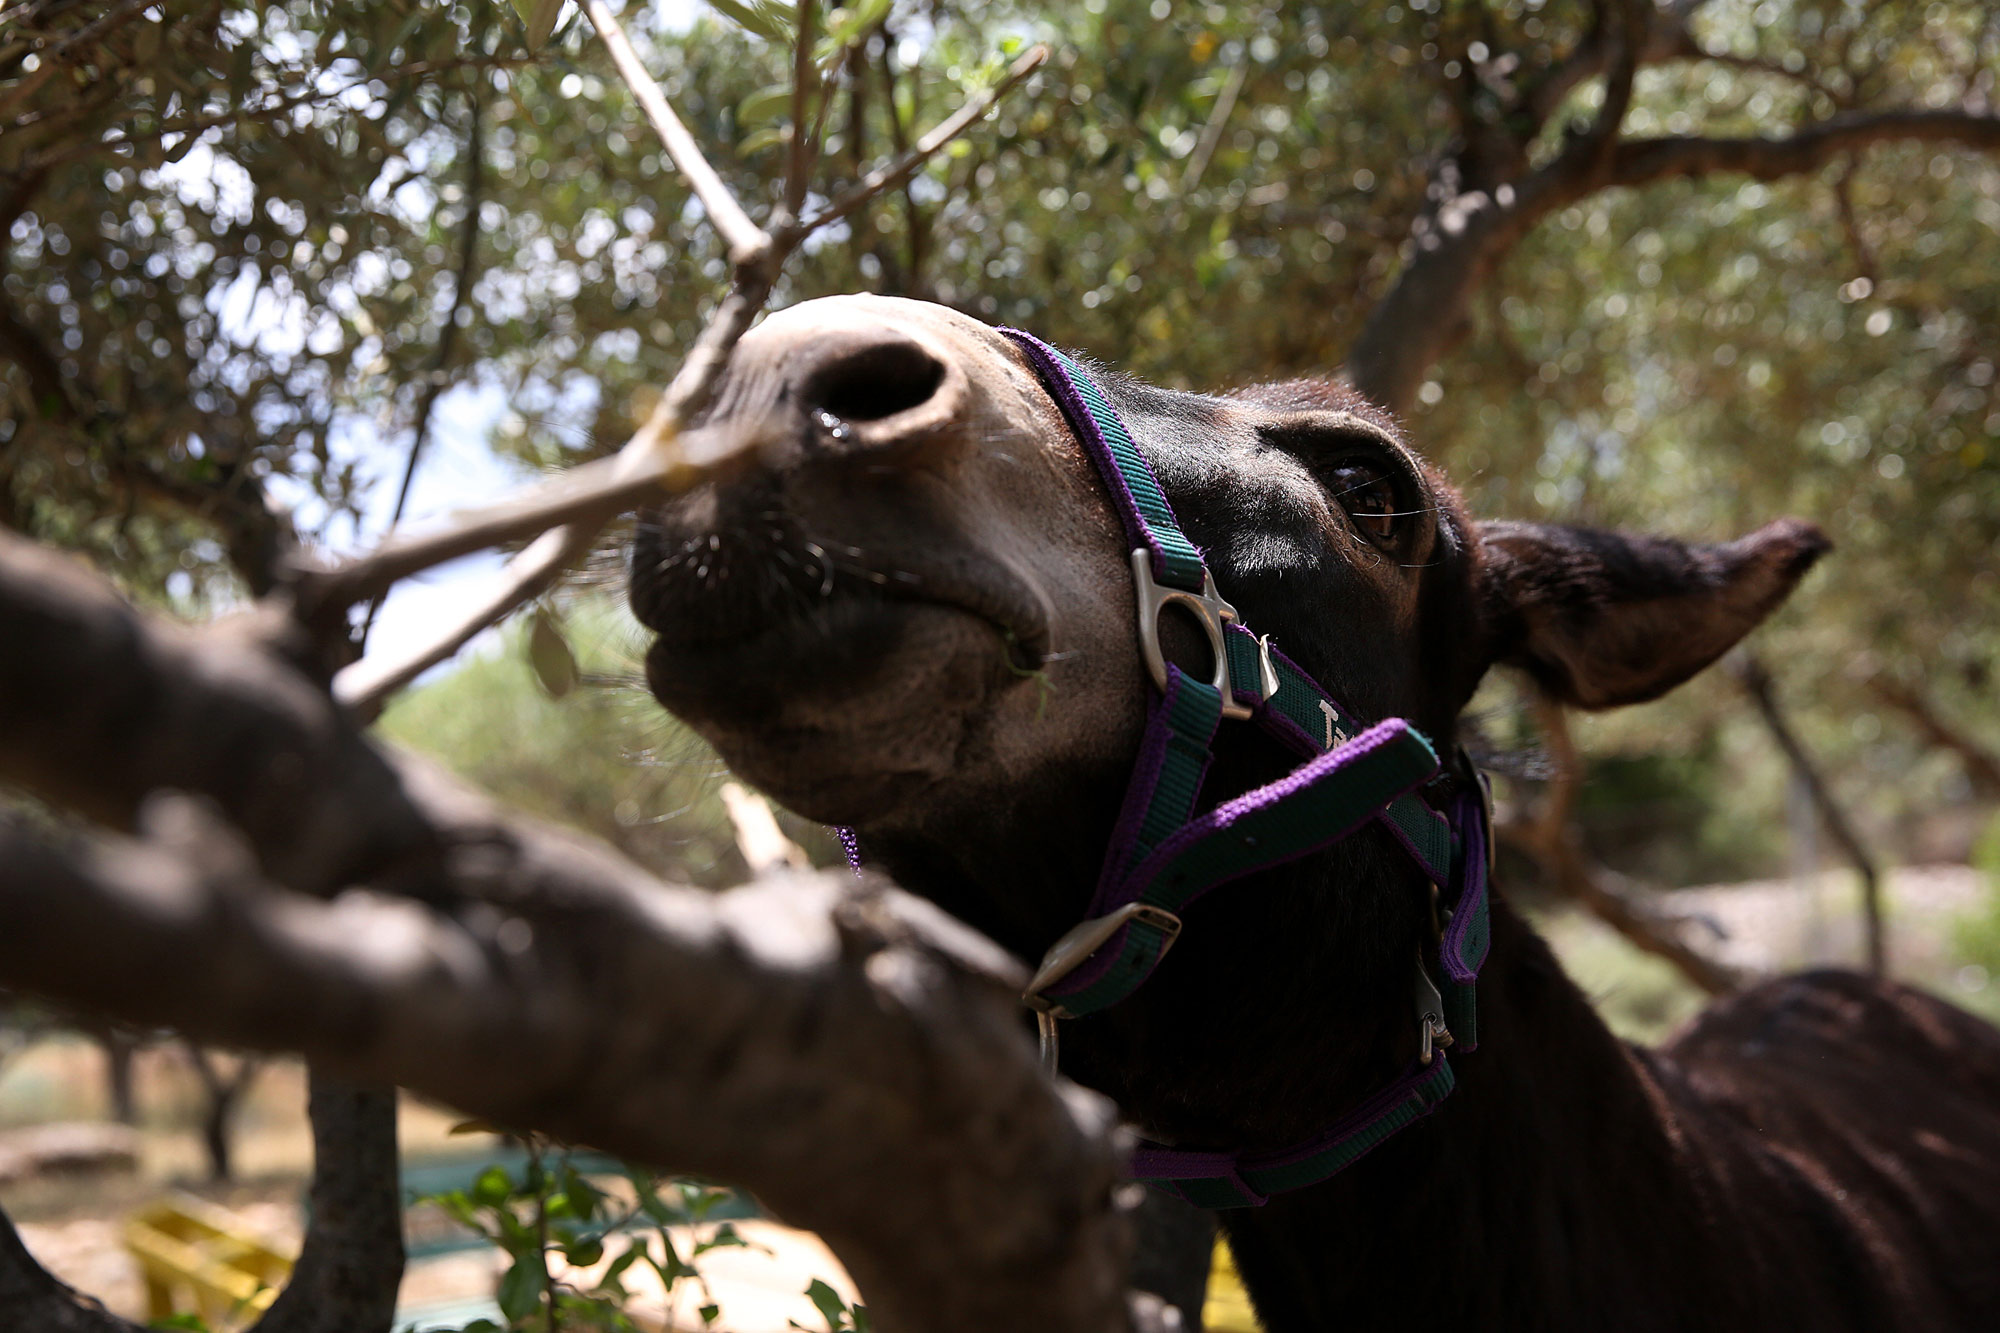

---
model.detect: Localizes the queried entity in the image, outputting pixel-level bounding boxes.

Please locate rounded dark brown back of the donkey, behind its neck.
[1656,971,2000,1331]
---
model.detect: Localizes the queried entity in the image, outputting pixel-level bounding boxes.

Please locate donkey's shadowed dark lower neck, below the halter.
[1224,903,1730,1333]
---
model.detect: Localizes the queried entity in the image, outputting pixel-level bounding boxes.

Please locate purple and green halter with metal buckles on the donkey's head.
[1000,328,1492,1209]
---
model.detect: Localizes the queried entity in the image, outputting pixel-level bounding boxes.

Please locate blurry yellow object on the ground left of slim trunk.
[126,1193,292,1331]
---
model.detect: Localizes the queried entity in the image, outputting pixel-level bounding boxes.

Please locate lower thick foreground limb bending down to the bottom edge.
[0,811,1126,1333]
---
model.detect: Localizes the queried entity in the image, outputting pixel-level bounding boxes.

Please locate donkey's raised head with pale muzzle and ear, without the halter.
[632,296,1826,1131]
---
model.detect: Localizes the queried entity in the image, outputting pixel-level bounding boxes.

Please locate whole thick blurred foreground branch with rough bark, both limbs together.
[0,540,1128,1331]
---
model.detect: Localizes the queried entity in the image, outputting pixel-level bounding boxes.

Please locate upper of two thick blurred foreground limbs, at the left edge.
[0,534,432,893]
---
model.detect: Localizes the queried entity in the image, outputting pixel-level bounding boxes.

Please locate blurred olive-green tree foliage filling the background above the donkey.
[0,0,2000,920]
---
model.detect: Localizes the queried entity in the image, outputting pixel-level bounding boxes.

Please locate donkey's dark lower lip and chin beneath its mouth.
[646,600,1022,825]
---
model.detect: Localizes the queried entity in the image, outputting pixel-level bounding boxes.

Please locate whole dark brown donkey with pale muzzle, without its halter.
[632,296,2000,1333]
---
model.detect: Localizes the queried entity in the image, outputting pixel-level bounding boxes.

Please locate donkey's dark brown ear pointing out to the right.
[1478,518,1832,709]
